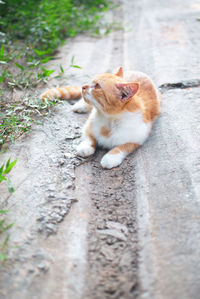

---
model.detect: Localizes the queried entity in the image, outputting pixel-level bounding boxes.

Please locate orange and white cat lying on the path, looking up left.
[41,67,161,169]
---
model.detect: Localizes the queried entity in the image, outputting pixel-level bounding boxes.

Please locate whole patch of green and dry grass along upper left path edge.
[0,0,110,149]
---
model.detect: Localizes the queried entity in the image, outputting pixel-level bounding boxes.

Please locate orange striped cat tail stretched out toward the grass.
[40,86,82,100]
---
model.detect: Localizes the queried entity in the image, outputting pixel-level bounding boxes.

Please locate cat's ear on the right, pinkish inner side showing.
[116,83,139,102]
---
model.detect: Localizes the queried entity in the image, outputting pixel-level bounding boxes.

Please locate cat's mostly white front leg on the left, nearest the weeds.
[76,120,96,157]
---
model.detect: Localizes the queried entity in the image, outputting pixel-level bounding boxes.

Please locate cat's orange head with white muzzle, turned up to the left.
[82,67,139,114]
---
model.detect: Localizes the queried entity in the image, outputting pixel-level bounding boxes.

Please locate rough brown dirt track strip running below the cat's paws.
[83,151,138,299]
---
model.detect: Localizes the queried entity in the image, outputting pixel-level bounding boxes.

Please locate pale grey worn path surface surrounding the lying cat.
[0,0,200,299]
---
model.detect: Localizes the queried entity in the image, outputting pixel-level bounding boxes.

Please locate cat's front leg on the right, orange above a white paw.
[101,143,140,169]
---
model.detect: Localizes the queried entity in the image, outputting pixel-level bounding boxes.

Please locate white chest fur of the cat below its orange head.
[86,108,151,149]
